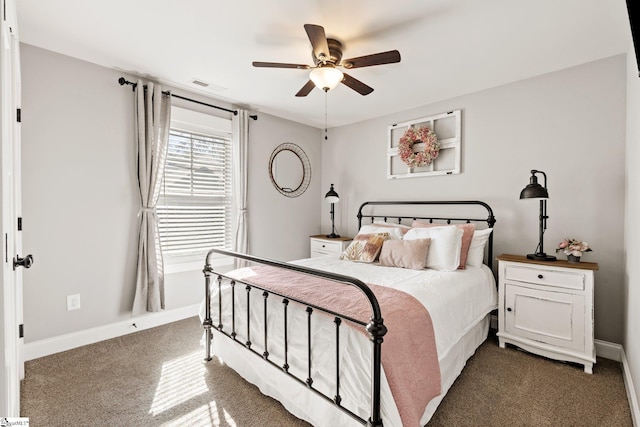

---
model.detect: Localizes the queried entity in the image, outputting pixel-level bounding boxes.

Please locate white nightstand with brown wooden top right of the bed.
[497,255,598,374]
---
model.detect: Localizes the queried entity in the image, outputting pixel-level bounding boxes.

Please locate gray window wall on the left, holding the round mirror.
[21,44,321,342]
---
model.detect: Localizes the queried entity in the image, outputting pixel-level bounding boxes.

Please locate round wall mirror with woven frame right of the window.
[269,143,311,197]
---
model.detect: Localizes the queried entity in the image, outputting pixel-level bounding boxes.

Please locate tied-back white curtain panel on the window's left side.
[132,80,171,315]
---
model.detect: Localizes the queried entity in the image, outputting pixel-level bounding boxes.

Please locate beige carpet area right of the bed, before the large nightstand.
[429,337,633,427]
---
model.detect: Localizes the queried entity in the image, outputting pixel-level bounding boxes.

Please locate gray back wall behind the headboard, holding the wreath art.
[322,56,626,343]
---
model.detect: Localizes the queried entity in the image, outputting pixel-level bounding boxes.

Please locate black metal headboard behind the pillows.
[358,200,496,269]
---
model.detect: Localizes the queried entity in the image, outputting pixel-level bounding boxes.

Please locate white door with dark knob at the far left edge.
[0,0,32,417]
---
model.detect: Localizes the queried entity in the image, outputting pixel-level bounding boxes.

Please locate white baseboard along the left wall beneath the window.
[23,304,200,362]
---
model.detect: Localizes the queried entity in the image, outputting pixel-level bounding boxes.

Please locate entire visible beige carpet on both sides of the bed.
[22,318,632,427]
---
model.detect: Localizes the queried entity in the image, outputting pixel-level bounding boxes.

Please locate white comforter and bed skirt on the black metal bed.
[202,256,497,426]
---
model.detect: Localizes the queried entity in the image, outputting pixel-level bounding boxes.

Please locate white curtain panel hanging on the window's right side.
[232,110,249,268]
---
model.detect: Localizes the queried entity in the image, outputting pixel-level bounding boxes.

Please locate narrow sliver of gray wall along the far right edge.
[623,47,640,423]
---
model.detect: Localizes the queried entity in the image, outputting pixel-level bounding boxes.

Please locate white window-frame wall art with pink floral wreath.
[387,110,462,179]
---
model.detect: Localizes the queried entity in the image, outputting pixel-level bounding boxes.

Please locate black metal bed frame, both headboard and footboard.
[202,201,496,426]
